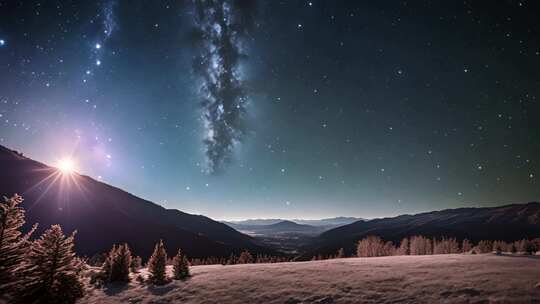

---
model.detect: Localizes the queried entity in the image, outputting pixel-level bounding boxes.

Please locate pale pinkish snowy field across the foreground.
[80,254,540,304]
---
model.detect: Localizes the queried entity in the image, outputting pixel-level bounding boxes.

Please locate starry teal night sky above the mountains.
[0,0,540,219]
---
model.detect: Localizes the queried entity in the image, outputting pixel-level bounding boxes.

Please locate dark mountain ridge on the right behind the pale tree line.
[301,202,540,259]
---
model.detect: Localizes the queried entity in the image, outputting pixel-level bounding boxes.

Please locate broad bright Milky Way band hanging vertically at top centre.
[193,0,254,173]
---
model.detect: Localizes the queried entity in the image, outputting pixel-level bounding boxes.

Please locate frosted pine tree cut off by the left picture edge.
[0,194,36,295]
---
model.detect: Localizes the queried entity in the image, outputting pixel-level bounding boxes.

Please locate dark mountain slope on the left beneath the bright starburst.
[0,146,275,257]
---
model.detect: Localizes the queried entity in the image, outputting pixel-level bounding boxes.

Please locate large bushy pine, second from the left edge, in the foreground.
[21,225,83,303]
